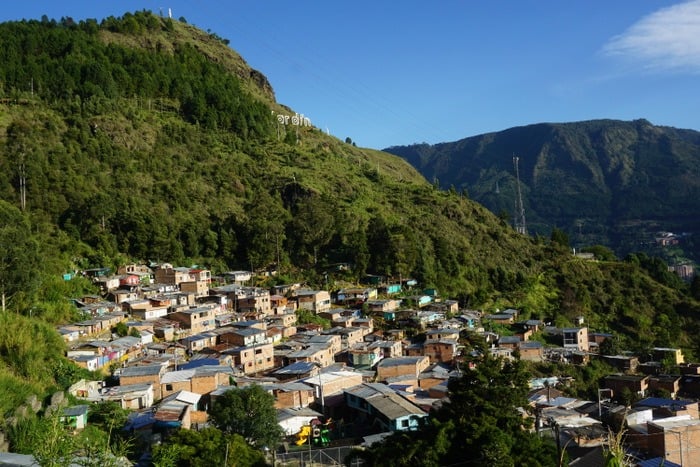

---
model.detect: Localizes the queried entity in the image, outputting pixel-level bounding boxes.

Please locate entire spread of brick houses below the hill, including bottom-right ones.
[52,264,700,465]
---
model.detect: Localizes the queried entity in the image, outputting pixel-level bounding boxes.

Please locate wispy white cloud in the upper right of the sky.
[603,0,700,73]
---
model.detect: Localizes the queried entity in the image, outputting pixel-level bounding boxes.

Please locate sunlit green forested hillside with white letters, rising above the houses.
[0,12,700,424]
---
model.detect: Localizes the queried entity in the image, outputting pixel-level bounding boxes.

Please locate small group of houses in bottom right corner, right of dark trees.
[529,365,700,467]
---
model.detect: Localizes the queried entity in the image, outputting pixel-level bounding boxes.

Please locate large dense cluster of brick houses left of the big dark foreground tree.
[59,264,470,437]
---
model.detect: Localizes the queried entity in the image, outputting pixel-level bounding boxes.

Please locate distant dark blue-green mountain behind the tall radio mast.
[385,120,700,260]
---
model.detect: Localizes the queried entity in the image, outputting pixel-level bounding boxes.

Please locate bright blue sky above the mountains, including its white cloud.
[0,0,700,149]
